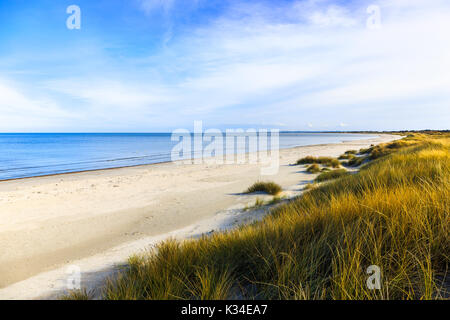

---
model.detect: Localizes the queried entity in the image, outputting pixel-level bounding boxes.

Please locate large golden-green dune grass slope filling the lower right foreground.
[80,134,450,299]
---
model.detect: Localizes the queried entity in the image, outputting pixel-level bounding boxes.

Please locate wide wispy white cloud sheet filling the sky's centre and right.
[0,0,450,131]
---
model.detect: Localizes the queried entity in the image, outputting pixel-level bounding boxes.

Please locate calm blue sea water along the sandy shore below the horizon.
[0,133,374,180]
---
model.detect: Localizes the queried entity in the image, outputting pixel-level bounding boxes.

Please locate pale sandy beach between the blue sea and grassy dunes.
[0,135,400,299]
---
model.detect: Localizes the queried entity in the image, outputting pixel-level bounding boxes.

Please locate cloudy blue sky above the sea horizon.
[0,0,450,132]
